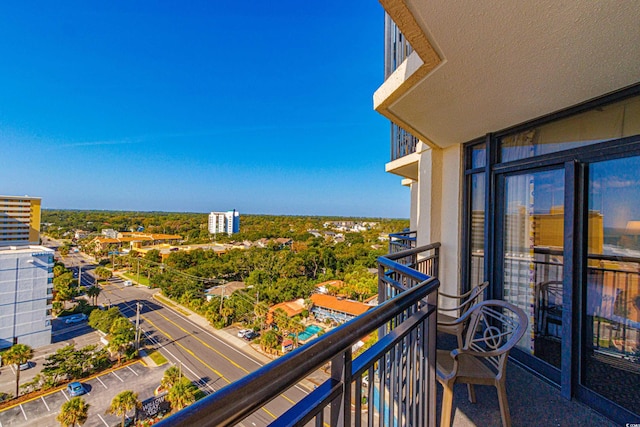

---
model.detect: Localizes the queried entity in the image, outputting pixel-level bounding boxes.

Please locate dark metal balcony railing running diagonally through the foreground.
[157,244,440,427]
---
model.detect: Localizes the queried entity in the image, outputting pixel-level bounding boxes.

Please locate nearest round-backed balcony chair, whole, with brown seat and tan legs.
[436,300,528,427]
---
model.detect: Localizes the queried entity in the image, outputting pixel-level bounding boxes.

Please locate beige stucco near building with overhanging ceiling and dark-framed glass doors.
[374,0,640,423]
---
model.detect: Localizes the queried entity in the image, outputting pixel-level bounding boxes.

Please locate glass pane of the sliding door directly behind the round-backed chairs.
[501,169,565,372]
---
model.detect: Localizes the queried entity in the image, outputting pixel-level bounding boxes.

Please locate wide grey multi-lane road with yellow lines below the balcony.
[56,246,316,426]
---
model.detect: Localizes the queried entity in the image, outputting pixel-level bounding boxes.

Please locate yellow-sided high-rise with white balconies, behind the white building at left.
[0,196,40,246]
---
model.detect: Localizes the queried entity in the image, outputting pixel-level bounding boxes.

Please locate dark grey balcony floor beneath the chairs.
[437,334,617,427]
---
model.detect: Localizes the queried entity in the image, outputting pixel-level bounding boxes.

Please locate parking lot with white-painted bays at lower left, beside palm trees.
[0,362,167,427]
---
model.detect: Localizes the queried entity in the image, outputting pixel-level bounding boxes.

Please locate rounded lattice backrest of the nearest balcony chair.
[463,300,528,376]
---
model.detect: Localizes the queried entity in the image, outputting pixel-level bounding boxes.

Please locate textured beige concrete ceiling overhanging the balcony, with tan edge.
[374,0,640,147]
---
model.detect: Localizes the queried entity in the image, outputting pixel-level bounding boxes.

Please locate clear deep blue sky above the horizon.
[0,0,409,218]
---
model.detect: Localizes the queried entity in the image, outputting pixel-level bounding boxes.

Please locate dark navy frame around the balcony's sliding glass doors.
[485,135,640,422]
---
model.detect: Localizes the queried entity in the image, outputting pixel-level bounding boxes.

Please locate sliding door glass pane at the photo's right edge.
[580,157,640,414]
